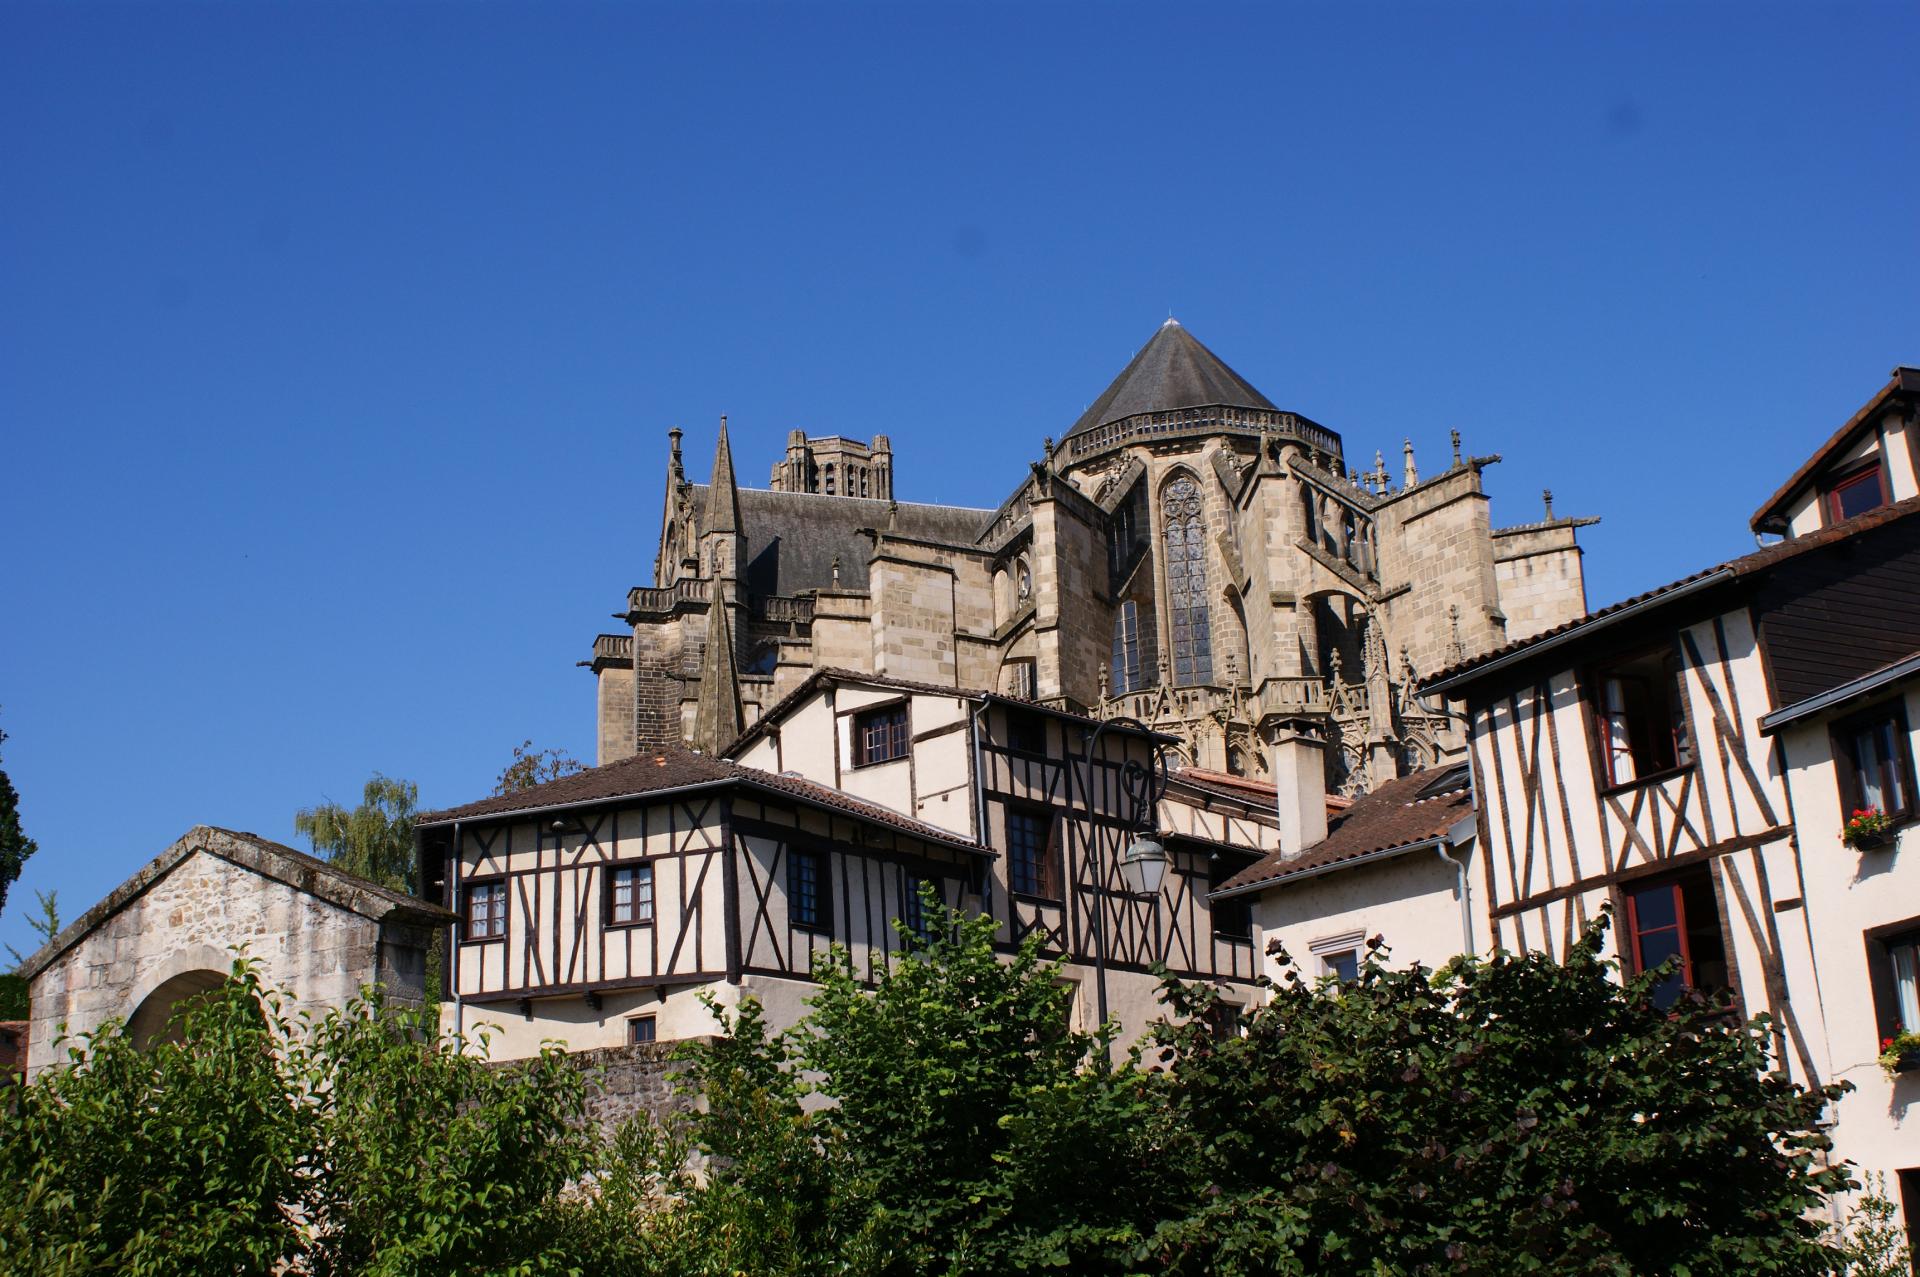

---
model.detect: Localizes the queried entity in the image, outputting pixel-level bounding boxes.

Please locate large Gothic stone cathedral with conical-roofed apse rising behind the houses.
[582,319,1592,795]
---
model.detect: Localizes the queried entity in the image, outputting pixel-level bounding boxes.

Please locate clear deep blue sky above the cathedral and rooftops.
[0,4,1920,949]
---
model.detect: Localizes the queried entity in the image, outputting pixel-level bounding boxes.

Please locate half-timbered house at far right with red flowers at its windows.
[1427,369,1920,1206]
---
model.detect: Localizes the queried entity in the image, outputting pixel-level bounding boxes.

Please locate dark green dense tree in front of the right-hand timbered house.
[1142,920,1849,1277]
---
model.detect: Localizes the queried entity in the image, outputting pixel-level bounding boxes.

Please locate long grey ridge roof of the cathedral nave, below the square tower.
[693,484,993,595]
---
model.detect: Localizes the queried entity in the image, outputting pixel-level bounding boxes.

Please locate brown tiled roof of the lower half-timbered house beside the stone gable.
[415,747,987,853]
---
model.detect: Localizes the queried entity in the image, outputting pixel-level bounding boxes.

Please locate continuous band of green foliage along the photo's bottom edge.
[0,897,1866,1277]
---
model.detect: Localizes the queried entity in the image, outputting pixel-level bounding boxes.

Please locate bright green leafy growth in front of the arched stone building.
[0,962,591,1277]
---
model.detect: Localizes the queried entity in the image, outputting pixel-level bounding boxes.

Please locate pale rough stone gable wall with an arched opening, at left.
[27,851,395,1072]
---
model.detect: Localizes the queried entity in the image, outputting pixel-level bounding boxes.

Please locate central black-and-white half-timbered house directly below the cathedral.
[419,670,1279,1056]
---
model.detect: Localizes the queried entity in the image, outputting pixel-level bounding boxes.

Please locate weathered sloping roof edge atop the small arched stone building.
[19,824,453,979]
